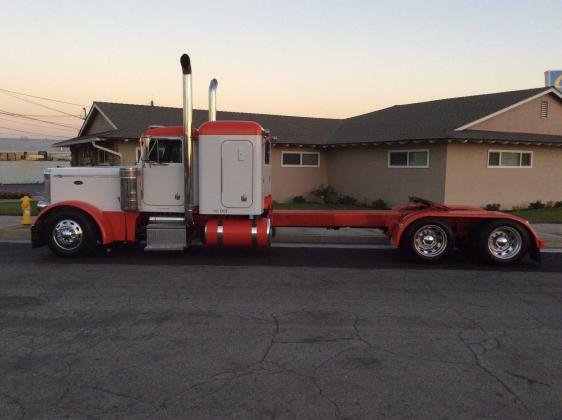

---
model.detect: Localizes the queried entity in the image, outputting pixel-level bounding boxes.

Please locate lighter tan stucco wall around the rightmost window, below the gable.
[445,144,562,210]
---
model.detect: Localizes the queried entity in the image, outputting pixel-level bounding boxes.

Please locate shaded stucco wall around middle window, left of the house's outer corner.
[328,143,446,206]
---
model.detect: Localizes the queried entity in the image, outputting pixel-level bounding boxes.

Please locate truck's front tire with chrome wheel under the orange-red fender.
[44,209,98,258]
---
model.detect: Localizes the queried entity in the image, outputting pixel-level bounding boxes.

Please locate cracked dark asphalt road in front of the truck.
[0,243,562,419]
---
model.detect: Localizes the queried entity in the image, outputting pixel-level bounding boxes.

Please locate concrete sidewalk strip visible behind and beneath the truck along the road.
[0,216,562,249]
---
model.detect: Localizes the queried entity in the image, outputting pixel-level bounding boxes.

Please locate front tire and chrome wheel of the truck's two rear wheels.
[400,219,455,263]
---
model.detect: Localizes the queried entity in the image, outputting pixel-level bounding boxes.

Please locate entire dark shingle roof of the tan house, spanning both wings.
[53,87,558,145]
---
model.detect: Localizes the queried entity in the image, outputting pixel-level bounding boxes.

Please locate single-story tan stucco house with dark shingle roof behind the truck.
[58,87,562,208]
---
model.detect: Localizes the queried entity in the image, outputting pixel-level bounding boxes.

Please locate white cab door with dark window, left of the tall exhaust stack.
[142,138,184,212]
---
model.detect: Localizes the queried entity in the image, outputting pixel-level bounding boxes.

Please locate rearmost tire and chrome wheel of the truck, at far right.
[476,220,529,265]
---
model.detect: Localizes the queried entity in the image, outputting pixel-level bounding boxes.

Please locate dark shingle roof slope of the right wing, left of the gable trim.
[327,87,551,144]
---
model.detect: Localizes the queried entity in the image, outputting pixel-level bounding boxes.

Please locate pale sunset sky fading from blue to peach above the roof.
[0,0,562,139]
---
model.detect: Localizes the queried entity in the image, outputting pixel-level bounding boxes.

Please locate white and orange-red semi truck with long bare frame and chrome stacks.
[31,54,543,265]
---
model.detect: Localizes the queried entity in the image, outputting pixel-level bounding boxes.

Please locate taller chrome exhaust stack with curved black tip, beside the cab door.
[180,54,194,230]
